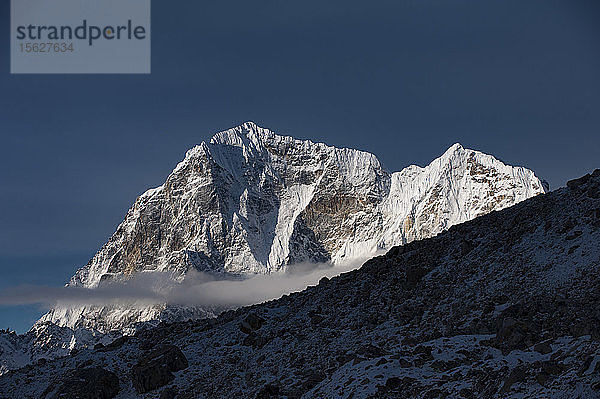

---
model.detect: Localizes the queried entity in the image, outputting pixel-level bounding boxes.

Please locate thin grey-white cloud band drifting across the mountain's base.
[0,258,376,308]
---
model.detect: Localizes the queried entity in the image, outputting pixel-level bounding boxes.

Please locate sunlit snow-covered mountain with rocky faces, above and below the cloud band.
[36,122,544,332]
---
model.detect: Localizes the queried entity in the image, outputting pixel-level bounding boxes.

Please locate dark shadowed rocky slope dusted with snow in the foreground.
[0,170,600,398]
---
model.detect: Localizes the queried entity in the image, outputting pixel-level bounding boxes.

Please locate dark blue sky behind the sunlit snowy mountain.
[0,0,600,331]
